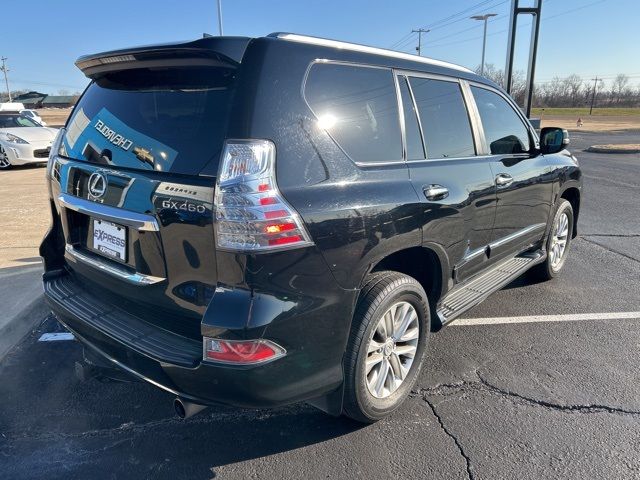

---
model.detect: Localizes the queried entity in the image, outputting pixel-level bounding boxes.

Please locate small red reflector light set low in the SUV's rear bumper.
[203,337,286,365]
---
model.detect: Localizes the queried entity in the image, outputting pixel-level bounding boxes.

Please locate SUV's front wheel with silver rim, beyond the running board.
[532,200,573,280]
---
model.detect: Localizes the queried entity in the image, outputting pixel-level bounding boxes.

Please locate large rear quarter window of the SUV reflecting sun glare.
[304,63,402,162]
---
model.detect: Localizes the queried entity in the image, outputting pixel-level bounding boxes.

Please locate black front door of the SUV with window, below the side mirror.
[470,85,553,260]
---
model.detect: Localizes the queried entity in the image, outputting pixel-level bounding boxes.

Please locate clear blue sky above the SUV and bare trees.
[5,0,640,93]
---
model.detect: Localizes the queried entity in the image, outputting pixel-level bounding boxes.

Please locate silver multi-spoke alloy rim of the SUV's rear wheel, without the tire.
[365,301,420,398]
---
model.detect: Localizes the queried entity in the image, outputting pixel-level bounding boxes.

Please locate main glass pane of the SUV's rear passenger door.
[409,77,476,158]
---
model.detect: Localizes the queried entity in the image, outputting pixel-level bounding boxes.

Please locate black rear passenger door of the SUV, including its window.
[397,73,496,281]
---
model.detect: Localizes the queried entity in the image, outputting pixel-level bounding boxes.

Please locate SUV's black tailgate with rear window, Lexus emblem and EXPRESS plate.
[52,60,235,338]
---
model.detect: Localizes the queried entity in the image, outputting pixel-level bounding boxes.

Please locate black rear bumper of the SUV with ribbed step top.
[44,272,352,408]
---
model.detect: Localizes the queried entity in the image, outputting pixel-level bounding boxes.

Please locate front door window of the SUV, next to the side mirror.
[471,87,530,155]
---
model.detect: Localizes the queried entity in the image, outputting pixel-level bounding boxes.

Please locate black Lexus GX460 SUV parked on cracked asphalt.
[40,33,581,422]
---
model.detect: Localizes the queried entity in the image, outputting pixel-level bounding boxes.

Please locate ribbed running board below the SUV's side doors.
[437,250,547,325]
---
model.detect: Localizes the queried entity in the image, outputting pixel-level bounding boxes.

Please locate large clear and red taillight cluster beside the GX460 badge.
[215,140,312,252]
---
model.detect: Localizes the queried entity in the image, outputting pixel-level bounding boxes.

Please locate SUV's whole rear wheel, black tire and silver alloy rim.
[343,271,430,423]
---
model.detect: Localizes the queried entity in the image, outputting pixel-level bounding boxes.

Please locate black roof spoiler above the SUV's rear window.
[76,37,251,80]
